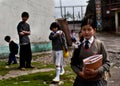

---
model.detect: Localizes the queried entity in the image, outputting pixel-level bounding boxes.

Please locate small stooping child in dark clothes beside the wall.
[4,36,18,65]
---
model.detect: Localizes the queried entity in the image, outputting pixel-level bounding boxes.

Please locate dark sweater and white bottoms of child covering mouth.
[49,30,67,66]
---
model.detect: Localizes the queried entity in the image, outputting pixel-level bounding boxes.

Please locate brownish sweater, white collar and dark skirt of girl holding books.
[71,36,110,86]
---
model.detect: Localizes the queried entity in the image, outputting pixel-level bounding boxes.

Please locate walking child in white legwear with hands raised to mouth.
[49,22,67,82]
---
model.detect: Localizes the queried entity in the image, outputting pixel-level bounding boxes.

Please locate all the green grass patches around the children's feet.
[0,54,75,86]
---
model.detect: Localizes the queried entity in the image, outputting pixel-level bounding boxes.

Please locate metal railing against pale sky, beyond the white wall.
[55,5,86,21]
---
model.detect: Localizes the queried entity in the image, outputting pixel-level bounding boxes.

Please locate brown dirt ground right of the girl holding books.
[96,33,120,86]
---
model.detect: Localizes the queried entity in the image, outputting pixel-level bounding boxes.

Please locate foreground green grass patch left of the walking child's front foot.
[0,71,53,86]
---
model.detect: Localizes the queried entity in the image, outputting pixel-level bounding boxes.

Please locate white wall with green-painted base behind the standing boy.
[0,0,54,56]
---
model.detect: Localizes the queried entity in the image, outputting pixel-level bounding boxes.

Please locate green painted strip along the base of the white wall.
[0,42,52,58]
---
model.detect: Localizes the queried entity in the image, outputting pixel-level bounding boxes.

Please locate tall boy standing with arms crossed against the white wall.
[17,12,34,70]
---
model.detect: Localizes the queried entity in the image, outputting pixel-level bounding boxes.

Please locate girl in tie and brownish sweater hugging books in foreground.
[71,19,110,86]
